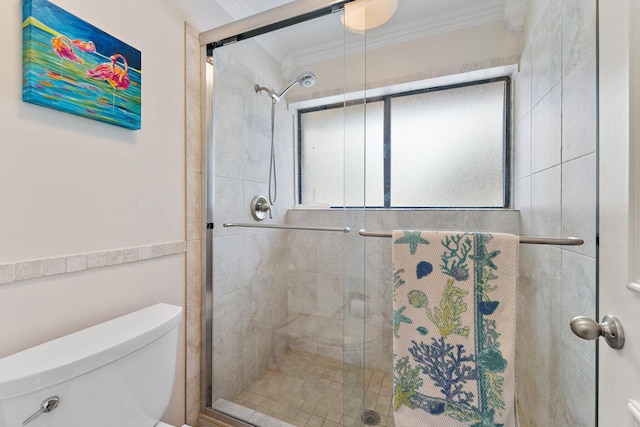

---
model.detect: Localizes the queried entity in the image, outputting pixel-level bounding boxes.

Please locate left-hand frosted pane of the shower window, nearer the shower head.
[299,102,384,206]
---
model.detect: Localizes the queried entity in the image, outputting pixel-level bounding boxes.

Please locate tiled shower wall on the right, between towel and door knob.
[514,0,596,426]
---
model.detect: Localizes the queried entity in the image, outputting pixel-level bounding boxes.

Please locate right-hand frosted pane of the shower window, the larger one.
[391,81,505,207]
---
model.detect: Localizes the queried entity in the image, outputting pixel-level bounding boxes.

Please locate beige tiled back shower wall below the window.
[287,209,520,371]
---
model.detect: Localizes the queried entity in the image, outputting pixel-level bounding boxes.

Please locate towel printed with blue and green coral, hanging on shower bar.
[392,230,518,427]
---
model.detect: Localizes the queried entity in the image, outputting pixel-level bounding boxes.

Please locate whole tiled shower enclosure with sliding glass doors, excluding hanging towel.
[201,0,595,426]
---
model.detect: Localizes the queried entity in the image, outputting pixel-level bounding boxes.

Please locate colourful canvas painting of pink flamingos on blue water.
[22,0,142,129]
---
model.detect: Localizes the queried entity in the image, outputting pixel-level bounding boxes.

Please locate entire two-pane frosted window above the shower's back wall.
[298,78,509,208]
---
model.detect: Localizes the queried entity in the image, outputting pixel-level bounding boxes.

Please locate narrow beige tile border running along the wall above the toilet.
[0,240,187,285]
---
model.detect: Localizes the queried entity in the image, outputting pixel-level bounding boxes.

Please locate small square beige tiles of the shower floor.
[232,350,395,427]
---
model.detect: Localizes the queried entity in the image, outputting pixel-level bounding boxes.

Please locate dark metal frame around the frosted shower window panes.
[296,76,513,209]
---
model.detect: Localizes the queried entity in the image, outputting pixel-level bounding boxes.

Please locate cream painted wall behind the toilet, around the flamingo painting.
[0,0,228,424]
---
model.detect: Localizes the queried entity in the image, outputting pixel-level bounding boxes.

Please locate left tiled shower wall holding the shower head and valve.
[208,48,293,400]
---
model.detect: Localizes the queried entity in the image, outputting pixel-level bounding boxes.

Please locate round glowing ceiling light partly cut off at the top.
[340,0,398,34]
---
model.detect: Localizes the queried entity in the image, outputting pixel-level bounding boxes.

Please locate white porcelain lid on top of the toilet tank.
[0,303,182,400]
